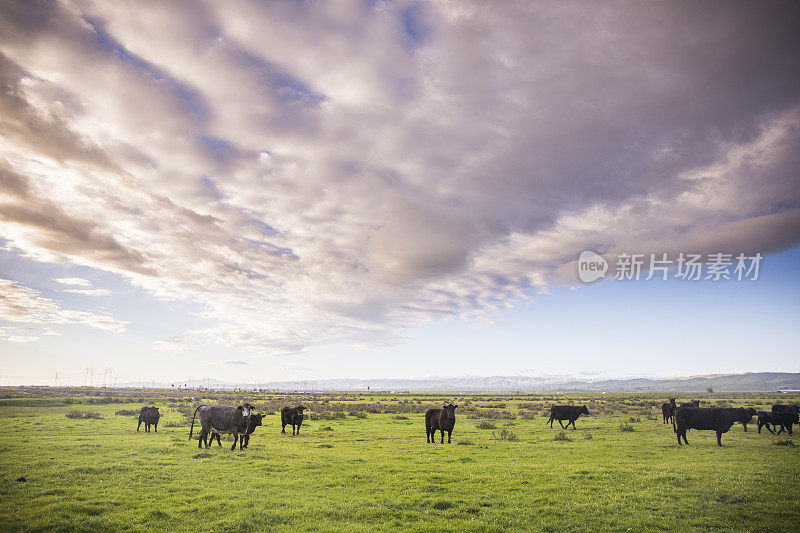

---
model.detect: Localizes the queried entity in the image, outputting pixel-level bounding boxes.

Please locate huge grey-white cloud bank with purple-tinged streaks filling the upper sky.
[0,0,800,354]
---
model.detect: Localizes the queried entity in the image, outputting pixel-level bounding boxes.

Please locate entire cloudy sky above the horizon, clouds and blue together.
[0,0,800,385]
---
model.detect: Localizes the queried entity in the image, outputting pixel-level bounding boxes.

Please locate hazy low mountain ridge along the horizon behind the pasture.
[116,372,800,394]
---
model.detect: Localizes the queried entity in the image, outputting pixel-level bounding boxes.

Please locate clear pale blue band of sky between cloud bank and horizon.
[0,243,800,384]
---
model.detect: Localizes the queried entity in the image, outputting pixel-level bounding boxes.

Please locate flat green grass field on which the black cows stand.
[0,388,800,532]
